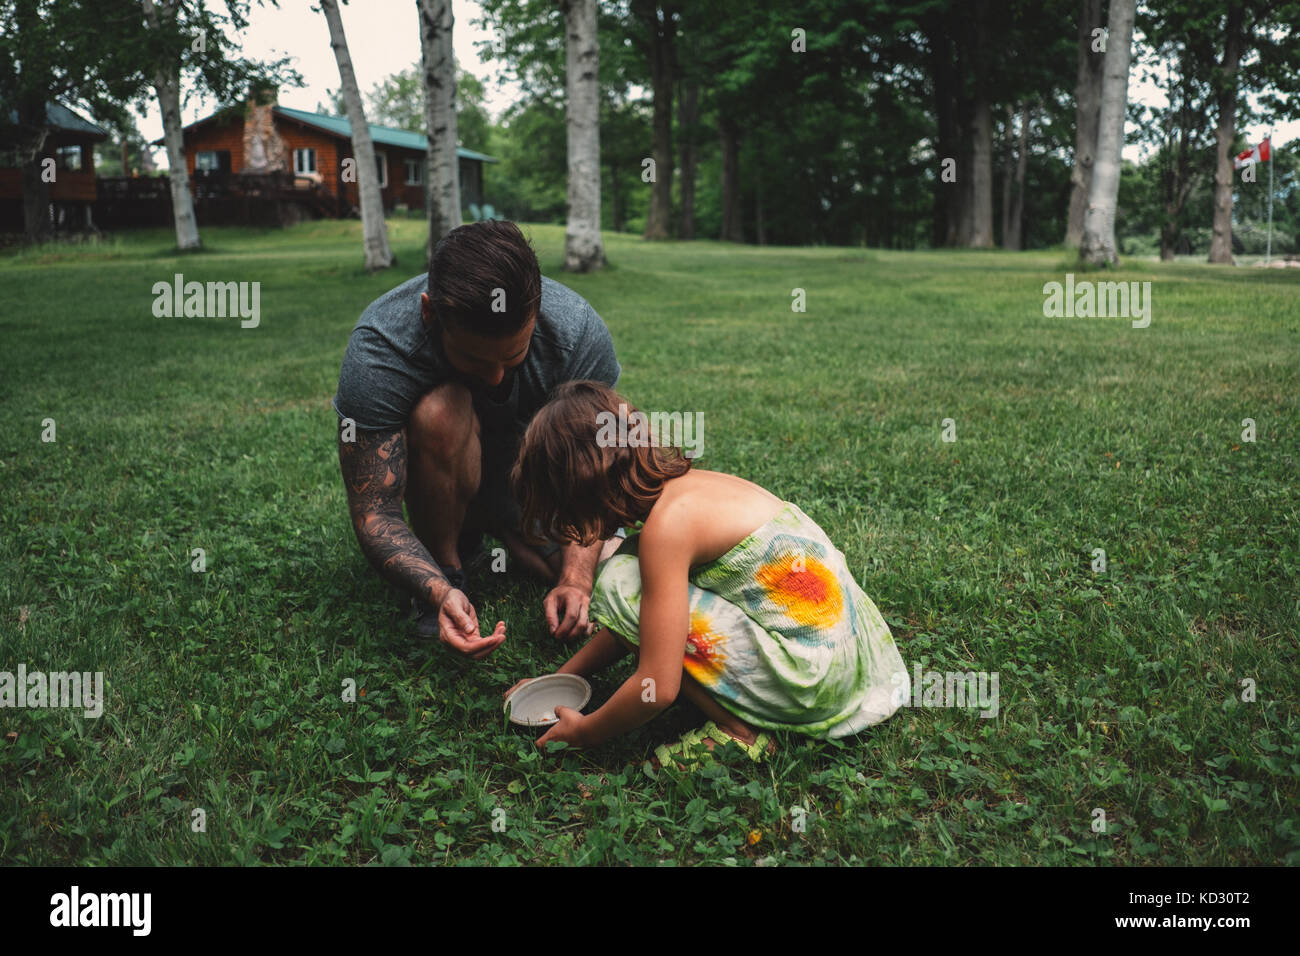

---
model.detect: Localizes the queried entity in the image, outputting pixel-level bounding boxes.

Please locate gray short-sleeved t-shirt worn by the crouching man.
[334,274,623,433]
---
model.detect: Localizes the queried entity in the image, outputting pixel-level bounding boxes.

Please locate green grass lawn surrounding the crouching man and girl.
[0,220,1300,865]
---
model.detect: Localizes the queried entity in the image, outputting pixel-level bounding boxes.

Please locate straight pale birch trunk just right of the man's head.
[562,0,605,272]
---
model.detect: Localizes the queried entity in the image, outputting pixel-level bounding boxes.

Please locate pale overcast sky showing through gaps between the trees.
[138,0,1300,168]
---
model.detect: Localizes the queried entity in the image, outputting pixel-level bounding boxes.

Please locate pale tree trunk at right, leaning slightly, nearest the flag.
[1079,0,1136,265]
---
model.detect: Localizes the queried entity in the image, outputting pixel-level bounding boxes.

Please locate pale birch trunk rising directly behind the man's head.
[416,0,460,263]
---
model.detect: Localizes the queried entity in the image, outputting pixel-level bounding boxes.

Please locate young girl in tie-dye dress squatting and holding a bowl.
[511,381,906,762]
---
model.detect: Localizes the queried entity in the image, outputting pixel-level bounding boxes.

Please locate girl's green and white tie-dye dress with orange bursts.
[589,502,907,737]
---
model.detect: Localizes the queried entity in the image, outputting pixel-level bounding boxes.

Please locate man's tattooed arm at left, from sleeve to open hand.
[338,429,506,659]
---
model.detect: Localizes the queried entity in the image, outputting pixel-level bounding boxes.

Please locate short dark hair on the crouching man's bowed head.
[429,220,542,338]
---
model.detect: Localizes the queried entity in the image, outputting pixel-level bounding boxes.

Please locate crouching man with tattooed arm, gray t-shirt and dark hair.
[334,221,621,659]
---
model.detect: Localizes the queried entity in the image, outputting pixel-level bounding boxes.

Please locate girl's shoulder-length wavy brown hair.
[510,381,690,546]
